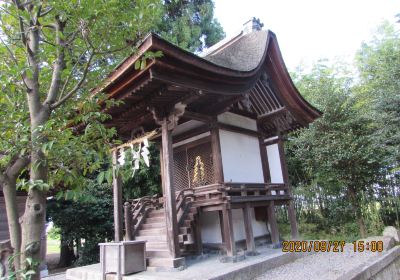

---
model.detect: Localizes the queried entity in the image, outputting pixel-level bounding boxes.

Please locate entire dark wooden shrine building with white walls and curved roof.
[97,21,321,267]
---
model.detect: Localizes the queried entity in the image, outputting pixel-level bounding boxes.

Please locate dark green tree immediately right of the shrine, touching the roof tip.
[291,63,385,237]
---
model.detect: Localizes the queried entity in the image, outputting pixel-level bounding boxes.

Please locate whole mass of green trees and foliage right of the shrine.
[288,22,400,239]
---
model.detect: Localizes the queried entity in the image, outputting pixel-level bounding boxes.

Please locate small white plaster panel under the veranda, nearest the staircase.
[200,211,222,244]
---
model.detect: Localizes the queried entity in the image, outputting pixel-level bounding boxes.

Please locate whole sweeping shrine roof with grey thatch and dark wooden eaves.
[94,28,321,137]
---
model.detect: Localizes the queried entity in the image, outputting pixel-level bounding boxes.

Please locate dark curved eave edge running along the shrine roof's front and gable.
[94,31,322,125]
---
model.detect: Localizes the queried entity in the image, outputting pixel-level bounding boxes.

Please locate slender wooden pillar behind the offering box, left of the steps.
[112,150,122,242]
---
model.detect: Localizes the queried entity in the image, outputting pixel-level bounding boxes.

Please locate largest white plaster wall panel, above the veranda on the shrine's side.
[219,130,264,183]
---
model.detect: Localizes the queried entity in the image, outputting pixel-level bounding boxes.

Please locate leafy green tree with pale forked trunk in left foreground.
[0,0,162,279]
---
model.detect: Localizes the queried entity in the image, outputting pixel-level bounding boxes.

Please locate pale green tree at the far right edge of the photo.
[356,22,400,226]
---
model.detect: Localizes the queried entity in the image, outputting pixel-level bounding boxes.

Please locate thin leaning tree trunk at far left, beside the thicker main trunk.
[3,177,21,271]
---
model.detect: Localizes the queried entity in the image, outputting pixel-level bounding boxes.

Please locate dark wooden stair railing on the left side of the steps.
[124,195,163,240]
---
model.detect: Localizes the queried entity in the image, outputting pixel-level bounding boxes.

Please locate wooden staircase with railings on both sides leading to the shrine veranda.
[125,191,201,268]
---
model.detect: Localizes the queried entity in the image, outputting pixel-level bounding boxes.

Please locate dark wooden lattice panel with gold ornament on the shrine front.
[174,142,214,191]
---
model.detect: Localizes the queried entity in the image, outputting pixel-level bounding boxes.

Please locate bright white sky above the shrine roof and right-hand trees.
[214,0,400,70]
